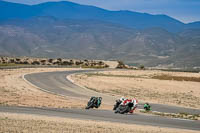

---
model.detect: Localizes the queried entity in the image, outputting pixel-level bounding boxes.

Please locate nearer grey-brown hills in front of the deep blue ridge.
[0,17,200,67]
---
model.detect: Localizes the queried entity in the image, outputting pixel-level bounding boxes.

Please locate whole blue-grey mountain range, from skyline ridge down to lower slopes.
[0,1,200,67]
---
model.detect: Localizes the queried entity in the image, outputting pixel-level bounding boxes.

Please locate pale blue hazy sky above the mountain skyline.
[4,0,200,23]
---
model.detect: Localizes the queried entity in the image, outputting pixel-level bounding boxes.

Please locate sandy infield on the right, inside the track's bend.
[71,70,200,108]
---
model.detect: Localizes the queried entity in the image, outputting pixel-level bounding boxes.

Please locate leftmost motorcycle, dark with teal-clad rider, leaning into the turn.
[85,97,102,109]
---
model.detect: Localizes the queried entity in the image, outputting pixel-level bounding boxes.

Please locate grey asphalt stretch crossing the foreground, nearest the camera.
[0,106,200,131]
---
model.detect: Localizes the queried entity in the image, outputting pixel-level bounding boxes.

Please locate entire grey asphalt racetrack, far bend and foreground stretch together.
[0,70,200,131]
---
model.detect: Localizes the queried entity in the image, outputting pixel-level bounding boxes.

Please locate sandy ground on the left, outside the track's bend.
[0,68,90,108]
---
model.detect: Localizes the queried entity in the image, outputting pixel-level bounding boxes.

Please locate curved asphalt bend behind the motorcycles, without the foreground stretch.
[24,70,200,114]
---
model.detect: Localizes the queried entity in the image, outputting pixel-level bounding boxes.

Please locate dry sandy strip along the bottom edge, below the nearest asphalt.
[0,113,197,133]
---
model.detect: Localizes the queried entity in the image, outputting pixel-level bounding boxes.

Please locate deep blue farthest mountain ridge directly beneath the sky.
[0,1,199,32]
